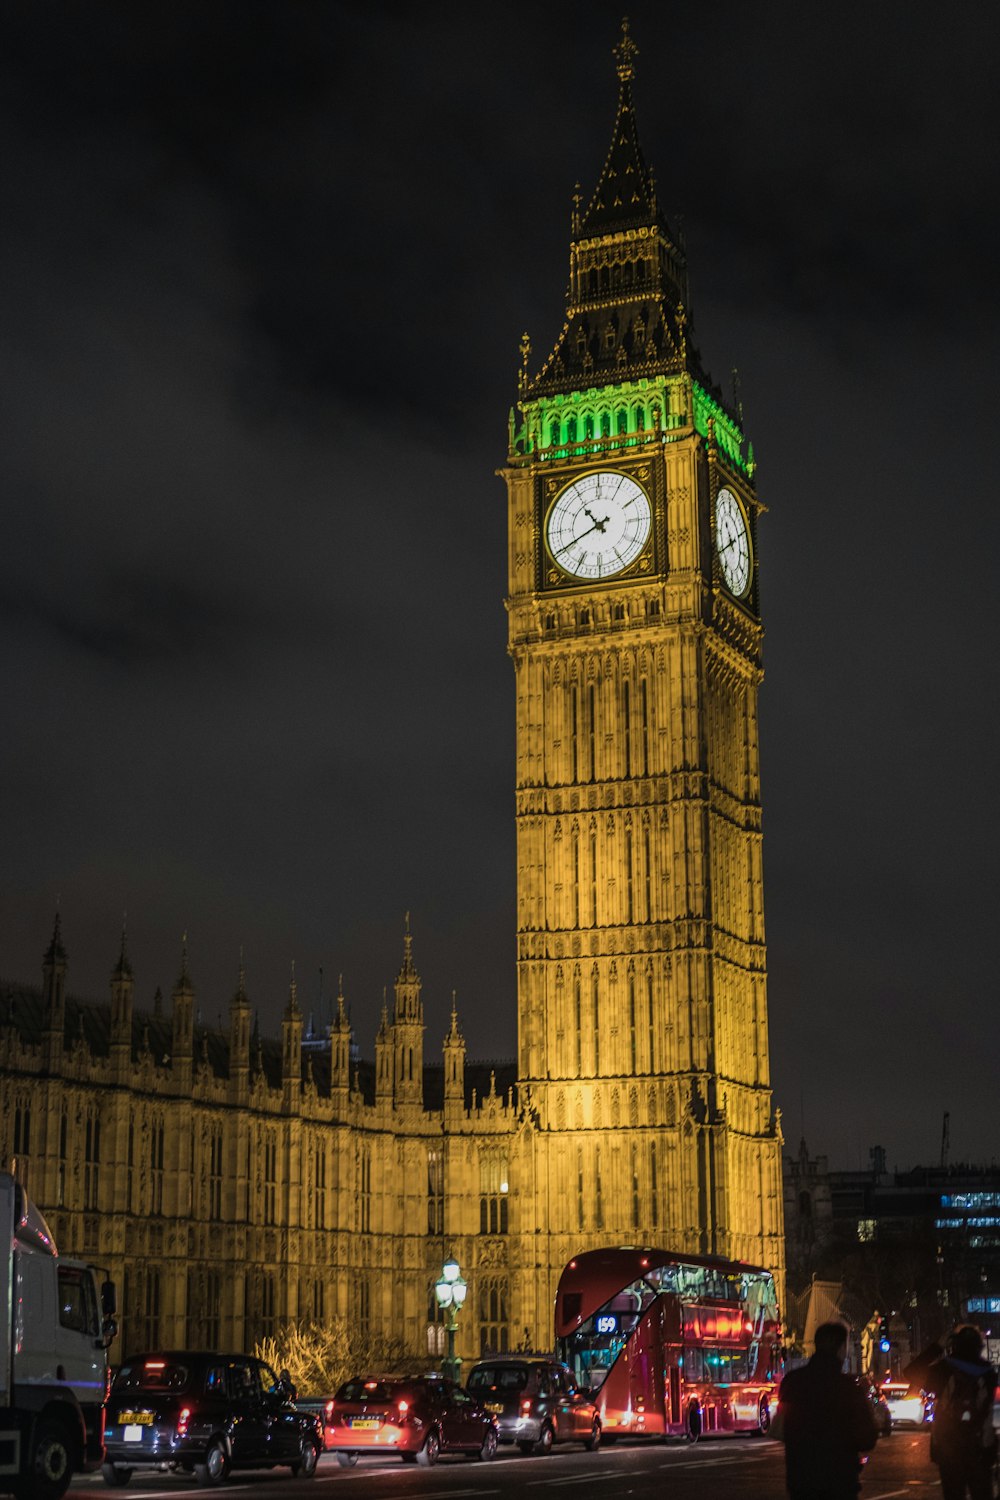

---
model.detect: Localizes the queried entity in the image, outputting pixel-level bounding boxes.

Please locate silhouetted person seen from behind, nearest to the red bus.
[778,1323,879,1500]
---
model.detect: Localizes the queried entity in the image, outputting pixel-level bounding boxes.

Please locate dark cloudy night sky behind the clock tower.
[0,0,1000,1167]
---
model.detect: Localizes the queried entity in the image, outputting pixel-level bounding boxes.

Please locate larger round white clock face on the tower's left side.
[546,473,652,578]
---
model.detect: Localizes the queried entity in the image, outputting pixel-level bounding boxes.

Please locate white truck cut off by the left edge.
[0,1172,115,1500]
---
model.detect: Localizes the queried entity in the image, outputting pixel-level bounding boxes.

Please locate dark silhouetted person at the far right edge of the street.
[927,1323,997,1500]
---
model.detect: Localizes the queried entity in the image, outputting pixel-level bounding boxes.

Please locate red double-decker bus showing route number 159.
[556,1248,783,1442]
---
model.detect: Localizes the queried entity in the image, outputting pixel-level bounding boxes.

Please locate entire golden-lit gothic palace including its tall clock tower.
[0,29,784,1358]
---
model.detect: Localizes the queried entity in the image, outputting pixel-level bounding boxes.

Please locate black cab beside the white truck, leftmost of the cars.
[102,1352,322,1485]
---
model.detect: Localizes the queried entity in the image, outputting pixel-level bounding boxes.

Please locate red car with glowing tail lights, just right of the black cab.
[325,1376,498,1464]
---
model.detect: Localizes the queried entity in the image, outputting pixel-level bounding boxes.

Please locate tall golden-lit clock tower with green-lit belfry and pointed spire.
[504,24,783,1296]
